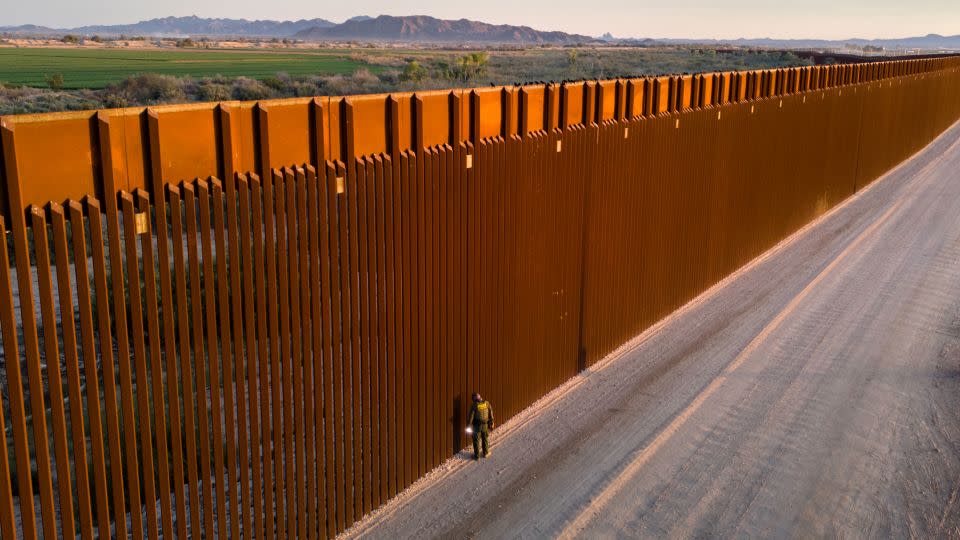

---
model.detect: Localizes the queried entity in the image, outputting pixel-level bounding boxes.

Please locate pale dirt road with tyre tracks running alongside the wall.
[345,125,960,538]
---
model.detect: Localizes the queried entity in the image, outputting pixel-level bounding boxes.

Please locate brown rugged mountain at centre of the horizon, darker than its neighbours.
[294,15,594,44]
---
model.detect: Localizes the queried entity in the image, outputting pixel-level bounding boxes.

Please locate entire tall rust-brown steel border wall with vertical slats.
[0,58,960,538]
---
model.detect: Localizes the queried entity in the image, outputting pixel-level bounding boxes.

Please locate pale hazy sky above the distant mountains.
[0,0,960,39]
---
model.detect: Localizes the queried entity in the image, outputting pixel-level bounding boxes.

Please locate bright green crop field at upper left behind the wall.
[0,48,383,88]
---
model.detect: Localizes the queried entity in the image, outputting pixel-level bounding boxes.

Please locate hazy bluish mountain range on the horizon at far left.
[0,16,335,37]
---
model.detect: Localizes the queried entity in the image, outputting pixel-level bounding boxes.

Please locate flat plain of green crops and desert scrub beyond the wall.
[0,45,810,115]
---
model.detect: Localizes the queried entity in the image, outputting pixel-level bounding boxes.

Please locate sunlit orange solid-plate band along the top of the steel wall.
[0,57,958,215]
